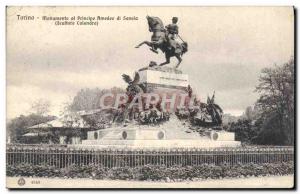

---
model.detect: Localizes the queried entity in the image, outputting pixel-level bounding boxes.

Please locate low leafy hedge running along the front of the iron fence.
[6,162,294,181]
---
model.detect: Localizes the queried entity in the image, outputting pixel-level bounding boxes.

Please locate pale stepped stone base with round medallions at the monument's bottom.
[76,117,241,149]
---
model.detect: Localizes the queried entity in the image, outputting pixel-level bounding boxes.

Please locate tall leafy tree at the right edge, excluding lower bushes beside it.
[256,58,295,145]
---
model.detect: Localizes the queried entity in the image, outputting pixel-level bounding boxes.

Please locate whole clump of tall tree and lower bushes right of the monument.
[227,59,295,145]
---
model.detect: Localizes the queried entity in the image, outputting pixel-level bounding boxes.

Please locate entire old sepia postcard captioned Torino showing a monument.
[6,6,295,189]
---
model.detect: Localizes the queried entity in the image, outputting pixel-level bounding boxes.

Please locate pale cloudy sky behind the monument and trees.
[6,7,294,118]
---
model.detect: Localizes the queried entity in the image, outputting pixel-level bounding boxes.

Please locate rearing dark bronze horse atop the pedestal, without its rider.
[135,16,188,68]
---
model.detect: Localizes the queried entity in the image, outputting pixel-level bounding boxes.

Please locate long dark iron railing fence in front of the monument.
[6,145,294,168]
